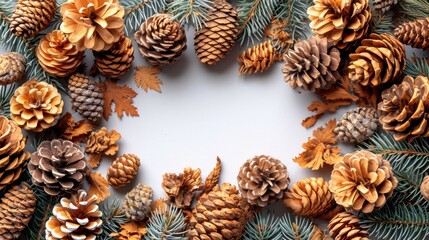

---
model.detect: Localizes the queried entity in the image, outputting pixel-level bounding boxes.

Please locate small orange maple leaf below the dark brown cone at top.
[134,66,162,93]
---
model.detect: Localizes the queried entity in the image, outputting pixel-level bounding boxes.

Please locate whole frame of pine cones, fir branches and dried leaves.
[0,0,429,240]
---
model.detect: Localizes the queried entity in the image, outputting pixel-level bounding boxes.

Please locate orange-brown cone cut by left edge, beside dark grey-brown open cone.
[0,116,30,190]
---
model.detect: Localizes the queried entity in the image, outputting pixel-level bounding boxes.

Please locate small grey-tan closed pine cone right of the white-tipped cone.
[122,183,153,221]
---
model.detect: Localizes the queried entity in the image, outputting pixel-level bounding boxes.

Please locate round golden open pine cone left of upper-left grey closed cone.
[10,79,64,132]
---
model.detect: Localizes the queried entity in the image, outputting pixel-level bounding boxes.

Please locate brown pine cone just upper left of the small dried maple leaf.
[91,37,134,78]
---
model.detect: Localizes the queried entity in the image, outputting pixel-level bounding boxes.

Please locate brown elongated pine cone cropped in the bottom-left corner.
[0,182,37,240]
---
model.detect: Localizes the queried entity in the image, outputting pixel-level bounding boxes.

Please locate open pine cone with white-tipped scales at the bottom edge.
[46,190,103,240]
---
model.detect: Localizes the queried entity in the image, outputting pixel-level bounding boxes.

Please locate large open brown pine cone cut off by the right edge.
[378,76,429,142]
